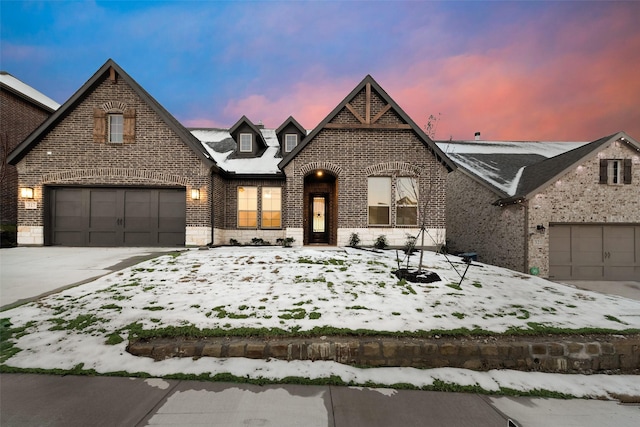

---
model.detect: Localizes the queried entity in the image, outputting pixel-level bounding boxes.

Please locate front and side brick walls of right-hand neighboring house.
[447,140,640,277]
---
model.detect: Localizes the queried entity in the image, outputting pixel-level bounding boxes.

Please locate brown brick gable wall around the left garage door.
[13,76,212,245]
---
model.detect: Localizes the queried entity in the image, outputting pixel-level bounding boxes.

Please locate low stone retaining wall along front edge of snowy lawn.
[127,334,640,374]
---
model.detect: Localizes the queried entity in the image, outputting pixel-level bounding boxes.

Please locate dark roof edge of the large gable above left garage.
[7,59,217,169]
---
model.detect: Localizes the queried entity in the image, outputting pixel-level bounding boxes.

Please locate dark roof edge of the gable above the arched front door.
[278,75,456,171]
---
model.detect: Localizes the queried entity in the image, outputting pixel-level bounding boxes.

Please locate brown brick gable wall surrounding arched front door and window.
[284,86,447,244]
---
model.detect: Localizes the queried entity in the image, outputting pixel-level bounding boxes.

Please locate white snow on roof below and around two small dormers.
[191,129,282,175]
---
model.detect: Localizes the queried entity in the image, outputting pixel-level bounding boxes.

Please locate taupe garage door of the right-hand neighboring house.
[549,224,640,280]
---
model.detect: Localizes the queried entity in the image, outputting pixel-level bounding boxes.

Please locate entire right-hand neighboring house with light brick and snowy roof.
[438,132,640,280]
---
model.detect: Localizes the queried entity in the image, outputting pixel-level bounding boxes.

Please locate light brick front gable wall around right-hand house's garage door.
[528,142,640,277]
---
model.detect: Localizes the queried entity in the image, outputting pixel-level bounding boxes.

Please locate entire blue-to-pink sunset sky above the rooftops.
[0,0,640,141]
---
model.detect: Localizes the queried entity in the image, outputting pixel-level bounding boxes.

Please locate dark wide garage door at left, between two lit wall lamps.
[45,188,186,246]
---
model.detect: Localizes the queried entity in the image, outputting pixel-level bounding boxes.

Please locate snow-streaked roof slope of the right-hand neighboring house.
[436,141,587,196]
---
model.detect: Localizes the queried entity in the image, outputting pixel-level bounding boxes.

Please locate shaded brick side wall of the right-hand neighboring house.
[447,170,526,271]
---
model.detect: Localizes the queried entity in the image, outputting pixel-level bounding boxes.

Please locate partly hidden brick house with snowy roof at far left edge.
[0,71,60,246]
